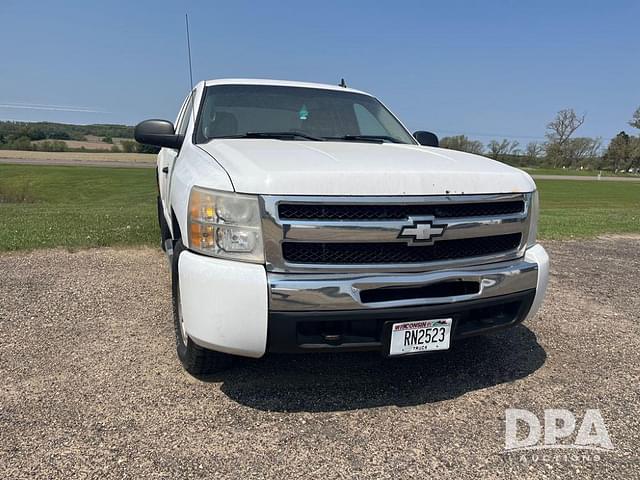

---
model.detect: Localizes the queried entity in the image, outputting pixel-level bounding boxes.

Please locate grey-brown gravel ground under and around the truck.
[0,238,640,479]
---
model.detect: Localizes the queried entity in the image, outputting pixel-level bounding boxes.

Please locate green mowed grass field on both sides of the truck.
[0,165,640,251]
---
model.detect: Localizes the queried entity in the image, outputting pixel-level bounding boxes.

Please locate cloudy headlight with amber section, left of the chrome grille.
[189,187,264,263]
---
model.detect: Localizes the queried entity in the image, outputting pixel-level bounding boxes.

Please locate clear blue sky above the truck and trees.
[0,0,640,143]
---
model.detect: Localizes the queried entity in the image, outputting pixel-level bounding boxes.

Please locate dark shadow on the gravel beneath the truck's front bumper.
[201,325,546,412]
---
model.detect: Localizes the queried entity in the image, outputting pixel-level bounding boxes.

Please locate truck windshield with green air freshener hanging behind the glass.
[196,85,415,144]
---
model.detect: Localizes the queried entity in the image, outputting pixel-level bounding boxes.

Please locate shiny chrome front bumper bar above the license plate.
[267,255,546,311]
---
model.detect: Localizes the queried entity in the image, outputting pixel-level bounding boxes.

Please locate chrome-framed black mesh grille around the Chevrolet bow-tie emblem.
[261,194,531,273]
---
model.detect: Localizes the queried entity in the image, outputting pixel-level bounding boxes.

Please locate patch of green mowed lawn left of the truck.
[0,165,160,250]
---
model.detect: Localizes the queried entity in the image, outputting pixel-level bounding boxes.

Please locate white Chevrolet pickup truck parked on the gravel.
[135,80,549,375]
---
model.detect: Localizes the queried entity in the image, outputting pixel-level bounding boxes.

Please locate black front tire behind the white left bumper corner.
[171,240,233,376]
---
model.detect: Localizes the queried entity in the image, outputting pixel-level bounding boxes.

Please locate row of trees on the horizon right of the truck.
[440,108,640,173]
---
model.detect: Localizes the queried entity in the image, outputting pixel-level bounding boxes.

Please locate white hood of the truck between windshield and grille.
[198,139,535,195]
